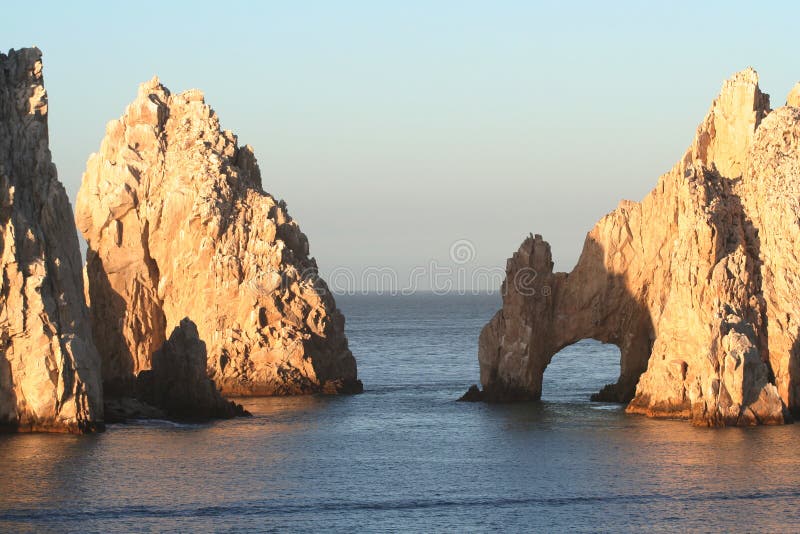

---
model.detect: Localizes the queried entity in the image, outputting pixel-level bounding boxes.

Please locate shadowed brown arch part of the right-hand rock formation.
[479,235,654,402]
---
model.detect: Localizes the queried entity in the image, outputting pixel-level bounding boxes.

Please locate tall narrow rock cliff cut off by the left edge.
[0,48,103,432]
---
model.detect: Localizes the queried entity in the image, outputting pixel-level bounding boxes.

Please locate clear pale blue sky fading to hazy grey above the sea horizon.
[6,0,800,294]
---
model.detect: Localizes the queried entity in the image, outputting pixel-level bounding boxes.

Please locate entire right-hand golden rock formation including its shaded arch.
[479,69,800,426]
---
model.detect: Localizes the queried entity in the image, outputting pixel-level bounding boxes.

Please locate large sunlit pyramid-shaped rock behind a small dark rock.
[76,79,361,395]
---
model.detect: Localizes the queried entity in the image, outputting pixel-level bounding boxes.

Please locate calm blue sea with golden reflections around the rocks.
[0,295,800,532]
